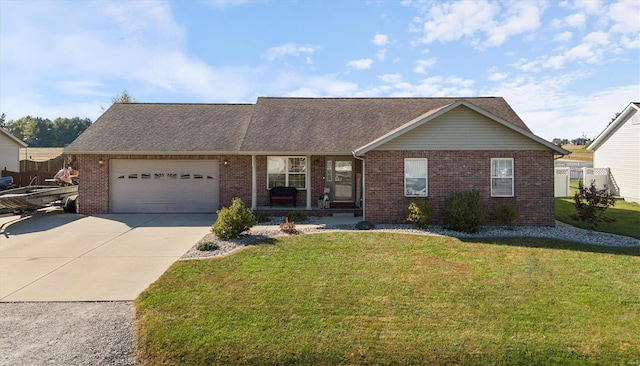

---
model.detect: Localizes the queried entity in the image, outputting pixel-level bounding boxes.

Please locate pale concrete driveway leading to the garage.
[0,210,215,302]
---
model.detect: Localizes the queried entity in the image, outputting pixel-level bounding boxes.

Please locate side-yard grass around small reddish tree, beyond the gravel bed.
[555,179,640,239]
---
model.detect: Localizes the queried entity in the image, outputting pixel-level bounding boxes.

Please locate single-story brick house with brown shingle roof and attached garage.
[65,97,569,226]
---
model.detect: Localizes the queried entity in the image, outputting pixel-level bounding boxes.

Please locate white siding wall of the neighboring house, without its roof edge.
[593,112,640,202]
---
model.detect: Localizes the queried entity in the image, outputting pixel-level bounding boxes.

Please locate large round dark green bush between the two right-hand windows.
[442,190,486,233]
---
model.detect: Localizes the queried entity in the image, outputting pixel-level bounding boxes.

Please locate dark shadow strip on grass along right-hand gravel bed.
[459,237,640,257]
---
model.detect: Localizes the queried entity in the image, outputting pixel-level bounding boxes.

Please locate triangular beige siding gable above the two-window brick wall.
[376,106,548,150]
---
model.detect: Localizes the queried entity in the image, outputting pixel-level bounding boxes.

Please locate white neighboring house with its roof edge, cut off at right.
[587,103,640,203]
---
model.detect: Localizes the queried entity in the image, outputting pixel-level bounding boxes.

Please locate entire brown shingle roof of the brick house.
[65,97,544,154]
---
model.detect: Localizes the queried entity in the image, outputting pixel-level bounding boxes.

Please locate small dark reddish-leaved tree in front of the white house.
[571,182,616,230]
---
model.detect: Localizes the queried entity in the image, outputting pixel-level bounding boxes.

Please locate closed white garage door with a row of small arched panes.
[109,160,219,213]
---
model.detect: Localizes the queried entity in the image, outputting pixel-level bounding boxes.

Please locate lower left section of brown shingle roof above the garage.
[65,103,254,154]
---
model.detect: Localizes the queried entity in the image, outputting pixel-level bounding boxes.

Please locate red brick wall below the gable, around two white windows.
[365,150,555,226]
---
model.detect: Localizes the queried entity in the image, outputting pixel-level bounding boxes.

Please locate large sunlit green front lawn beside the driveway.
[136,232,640,365]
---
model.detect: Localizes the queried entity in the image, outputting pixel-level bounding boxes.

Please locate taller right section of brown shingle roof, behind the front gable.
[241,97,530,153]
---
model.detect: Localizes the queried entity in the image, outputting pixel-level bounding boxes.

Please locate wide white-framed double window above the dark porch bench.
[267,156,307,189]
